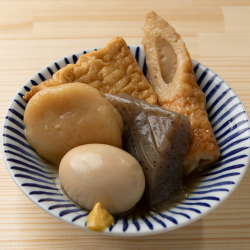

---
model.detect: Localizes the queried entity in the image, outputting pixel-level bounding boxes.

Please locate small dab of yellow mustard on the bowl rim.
[87,202,114,232]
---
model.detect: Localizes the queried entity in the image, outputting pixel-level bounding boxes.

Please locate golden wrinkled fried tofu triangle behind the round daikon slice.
[23,37,157,104]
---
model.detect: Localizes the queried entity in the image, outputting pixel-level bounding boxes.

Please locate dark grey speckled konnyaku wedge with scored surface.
[105,94,190,211]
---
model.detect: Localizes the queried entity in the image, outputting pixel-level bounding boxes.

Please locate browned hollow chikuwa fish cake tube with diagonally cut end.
[142,11,220,175]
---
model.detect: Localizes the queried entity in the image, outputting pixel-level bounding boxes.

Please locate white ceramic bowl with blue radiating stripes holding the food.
[1,45,250,236]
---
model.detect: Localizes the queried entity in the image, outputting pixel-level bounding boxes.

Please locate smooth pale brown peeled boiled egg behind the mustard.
[59,144,145,214]
